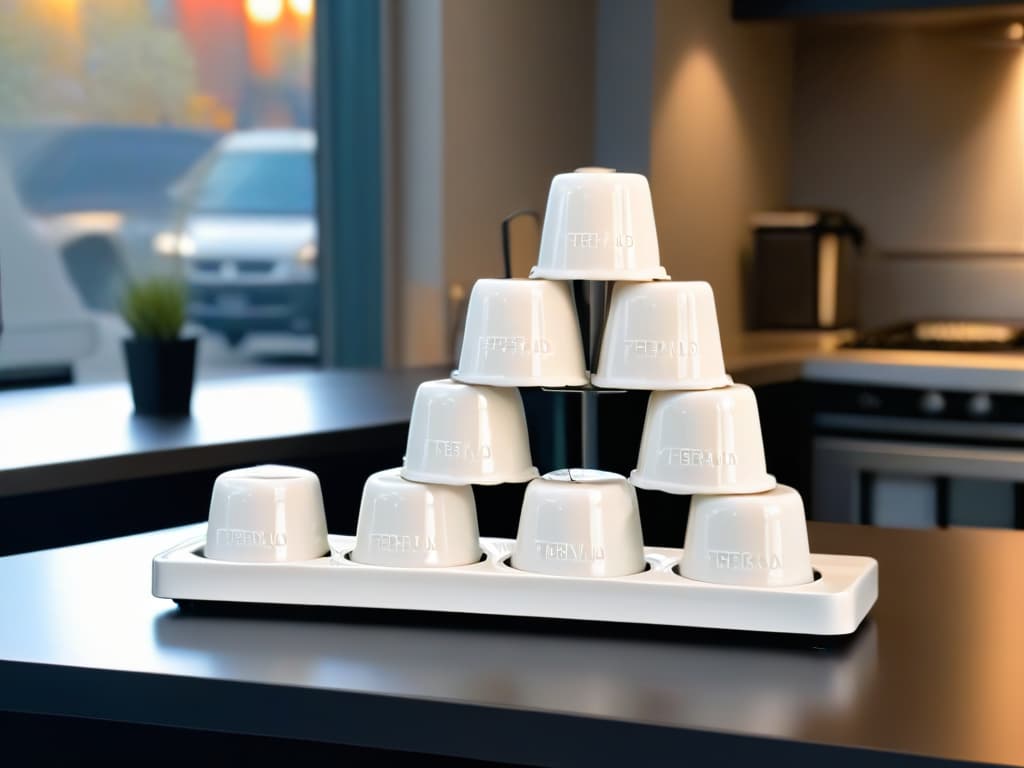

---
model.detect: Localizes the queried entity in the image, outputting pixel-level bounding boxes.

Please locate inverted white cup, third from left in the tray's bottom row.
[512,469,645,578]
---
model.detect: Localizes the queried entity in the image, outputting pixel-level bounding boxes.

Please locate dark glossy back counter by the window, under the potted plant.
[0,368,449,498]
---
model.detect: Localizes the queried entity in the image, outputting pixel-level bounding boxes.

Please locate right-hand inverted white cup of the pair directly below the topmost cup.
[593,282,732,390]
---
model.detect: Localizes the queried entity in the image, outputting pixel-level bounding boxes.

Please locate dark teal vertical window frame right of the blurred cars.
[313,0,386,368]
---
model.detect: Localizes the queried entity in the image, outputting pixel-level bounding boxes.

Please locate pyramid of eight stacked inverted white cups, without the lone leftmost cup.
[350,168,813,587]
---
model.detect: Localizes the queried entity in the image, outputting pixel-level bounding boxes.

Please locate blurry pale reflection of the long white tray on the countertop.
[154,611,878,738]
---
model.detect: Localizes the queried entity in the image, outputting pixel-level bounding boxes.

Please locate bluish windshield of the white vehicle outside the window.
[195,151,315,215]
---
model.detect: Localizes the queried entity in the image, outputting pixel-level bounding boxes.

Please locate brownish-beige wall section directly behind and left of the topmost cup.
[444,0,595,303]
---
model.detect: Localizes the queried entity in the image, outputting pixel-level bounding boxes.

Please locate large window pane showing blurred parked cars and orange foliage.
[0,0,319,387]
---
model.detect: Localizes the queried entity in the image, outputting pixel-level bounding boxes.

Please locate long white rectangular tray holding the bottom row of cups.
[153,536,879,635]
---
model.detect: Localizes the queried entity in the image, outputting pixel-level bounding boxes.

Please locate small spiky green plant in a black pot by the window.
[121,276,196,416]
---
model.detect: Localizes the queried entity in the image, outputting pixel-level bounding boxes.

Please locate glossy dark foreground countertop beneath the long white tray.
[0,520,1024,765]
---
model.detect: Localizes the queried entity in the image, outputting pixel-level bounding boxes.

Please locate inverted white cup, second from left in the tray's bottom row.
[350,469,481,568]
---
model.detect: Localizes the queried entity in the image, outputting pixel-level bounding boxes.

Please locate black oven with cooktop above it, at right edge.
[811,322,1024,528]
